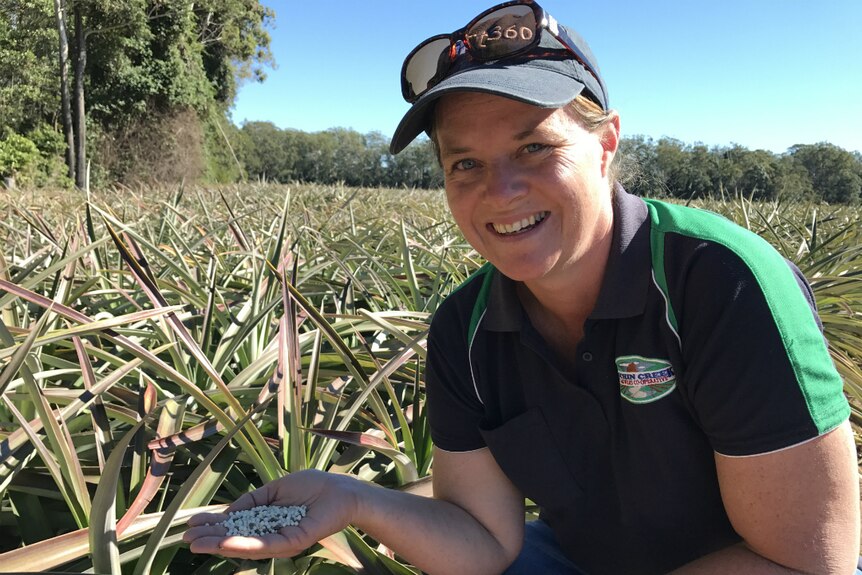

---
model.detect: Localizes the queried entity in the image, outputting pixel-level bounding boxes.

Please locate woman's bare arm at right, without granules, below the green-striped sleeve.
[675,422,860,575]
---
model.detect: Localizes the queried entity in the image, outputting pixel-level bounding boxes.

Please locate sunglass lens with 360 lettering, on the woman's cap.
[467,6,537,60]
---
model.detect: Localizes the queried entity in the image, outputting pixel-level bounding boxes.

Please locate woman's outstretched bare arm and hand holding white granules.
[184,448,524,575]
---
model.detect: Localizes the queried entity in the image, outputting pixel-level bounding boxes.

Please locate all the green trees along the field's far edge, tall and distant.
[0,0,862,204]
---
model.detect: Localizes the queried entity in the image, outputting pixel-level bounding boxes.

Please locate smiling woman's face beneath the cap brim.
[435,92,619,287]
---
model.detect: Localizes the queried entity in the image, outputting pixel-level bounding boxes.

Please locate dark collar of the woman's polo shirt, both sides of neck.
[483,184,652,331]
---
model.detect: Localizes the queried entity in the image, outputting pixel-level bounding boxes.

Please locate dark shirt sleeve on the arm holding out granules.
[425,300,485,451]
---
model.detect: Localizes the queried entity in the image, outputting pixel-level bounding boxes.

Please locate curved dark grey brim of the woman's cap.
[389,60,584,154]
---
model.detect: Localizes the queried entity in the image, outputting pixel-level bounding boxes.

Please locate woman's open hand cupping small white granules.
[183,470,357,559]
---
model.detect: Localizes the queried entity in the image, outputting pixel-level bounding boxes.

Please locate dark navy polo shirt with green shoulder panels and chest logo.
[426,187,850,574]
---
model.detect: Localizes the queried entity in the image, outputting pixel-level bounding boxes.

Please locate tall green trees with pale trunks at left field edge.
[0,0,275,187]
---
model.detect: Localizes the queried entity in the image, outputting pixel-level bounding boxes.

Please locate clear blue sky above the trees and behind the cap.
[233,0,862,152]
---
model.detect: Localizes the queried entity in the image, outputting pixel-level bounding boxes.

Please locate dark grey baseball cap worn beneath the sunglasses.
[389,25,609,154]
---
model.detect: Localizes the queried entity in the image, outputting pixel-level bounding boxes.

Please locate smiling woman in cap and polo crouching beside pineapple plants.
[186,1,860,574]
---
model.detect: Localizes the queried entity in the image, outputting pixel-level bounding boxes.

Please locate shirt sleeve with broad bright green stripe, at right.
[672,239,850,456]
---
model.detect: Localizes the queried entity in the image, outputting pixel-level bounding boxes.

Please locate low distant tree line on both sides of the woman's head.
[237,122,862,203]
